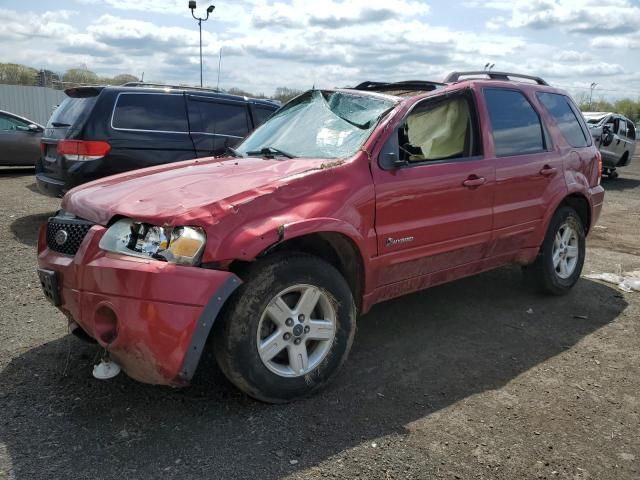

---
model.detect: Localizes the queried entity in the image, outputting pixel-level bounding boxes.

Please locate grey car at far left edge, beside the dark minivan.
[0,110,44,166]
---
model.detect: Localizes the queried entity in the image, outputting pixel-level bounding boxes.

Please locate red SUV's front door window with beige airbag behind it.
[398,95,479,164]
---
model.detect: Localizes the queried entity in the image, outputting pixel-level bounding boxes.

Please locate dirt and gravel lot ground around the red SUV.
[0,154,640,480]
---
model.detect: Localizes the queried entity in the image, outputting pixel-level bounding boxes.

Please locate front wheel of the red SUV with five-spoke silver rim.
[213,253,356,403]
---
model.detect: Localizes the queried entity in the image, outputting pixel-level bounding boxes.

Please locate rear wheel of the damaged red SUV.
[524,207,585,295]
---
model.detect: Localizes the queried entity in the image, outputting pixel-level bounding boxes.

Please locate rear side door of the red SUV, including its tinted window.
[483,88,566,256]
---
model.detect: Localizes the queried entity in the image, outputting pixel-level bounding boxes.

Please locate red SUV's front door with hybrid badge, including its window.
[373,91,495,286]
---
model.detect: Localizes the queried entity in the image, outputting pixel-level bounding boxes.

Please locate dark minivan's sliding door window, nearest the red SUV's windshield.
[190,97,249,138]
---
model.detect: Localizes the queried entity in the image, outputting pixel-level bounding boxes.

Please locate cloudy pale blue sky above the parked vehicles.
[0,0,640,99]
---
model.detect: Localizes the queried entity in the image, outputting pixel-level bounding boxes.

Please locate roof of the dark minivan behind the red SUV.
[64,82,280,108]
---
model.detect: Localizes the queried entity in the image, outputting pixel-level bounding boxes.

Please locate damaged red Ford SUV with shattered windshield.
[38,72,604,402]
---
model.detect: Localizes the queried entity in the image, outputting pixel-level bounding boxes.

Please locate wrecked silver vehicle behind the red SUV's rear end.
[582,112,636,178]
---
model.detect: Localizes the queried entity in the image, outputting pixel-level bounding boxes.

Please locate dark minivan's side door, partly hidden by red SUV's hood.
[187,95,251,157]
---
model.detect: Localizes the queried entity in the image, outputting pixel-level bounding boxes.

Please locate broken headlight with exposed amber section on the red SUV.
[100,219,206,265]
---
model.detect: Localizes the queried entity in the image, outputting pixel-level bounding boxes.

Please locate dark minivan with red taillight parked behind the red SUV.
[36,83,279,197]
